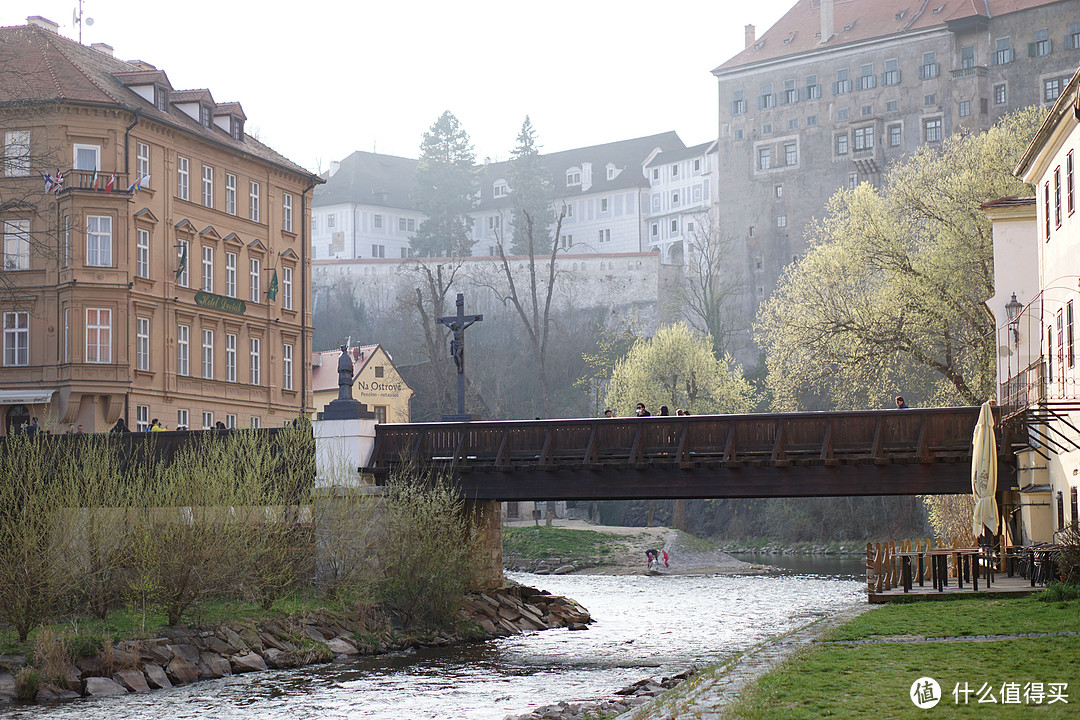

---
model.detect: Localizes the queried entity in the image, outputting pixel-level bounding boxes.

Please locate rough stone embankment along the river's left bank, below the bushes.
[0,586,592,702]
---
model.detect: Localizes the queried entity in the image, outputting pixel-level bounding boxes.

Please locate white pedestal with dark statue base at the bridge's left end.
[312,399,376,488]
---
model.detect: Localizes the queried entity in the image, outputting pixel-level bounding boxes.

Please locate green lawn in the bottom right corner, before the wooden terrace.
[724,596,1080,720]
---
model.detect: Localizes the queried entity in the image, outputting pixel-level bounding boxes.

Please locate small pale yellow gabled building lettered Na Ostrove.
[311,344,413,422]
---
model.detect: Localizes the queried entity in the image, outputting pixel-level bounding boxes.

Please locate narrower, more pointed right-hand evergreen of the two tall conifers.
[509,116,554,255]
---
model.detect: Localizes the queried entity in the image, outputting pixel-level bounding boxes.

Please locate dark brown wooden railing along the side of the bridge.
[368,407,993,473]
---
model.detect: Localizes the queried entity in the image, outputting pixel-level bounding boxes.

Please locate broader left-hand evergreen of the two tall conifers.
[410,110,477,257]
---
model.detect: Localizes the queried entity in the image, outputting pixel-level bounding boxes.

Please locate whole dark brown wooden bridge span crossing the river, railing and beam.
[363,407,1013,501]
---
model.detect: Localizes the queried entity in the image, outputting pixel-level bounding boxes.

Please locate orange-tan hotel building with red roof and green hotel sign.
[0,17,321,432]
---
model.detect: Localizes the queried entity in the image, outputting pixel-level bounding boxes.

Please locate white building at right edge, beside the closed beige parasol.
[987,64,1080,542]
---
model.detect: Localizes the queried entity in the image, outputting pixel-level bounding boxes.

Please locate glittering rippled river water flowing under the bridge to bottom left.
[6,558,866,720]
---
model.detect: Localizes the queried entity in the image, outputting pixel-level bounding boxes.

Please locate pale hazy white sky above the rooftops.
[0,0,795,169]
